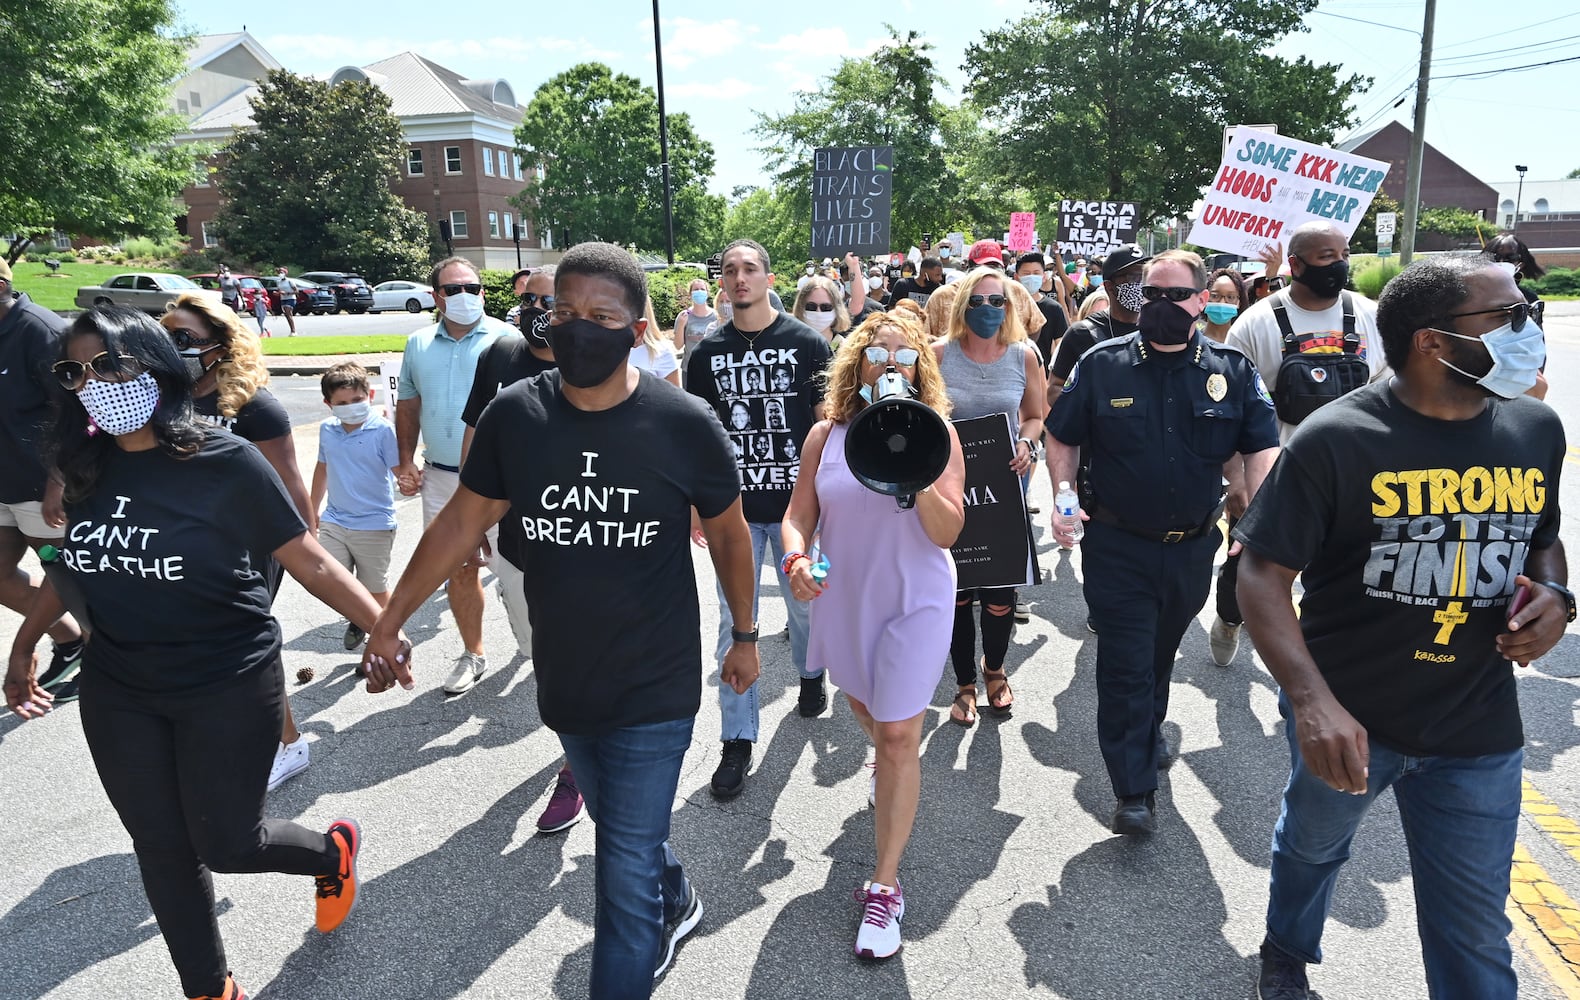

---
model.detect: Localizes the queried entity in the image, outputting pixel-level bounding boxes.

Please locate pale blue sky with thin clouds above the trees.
[175,0,1580,200]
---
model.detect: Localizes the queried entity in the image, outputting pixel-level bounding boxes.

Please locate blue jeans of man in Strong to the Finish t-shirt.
[1267,694,1525,1000]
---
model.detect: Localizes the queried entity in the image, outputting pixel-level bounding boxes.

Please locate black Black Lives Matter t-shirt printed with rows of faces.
[686,313,833,524]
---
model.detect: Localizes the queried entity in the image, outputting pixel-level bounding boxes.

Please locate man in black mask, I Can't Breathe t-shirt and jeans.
[367,243,758,997]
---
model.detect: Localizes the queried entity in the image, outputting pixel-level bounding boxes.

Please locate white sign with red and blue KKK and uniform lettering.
[1190,128,1389,258]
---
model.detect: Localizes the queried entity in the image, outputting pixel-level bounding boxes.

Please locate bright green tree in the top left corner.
[0,0,193,262]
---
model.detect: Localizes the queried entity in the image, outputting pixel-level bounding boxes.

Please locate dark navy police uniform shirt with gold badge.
[1048,333,1278,531]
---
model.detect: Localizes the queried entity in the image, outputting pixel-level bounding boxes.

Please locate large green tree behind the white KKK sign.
[965,0,1370,218]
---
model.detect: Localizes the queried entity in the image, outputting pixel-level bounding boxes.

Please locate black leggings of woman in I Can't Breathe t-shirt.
[81,659,340,997]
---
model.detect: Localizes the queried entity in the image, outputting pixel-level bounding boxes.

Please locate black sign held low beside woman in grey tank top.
[950,414,1036,591]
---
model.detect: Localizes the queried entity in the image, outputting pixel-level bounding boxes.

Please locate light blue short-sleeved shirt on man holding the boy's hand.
[397,316,517,468]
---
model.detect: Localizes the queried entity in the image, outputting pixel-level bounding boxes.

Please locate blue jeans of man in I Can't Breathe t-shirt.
[559,719,694,1000]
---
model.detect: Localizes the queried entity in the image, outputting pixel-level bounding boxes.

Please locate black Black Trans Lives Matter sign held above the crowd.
[812,145,894,258]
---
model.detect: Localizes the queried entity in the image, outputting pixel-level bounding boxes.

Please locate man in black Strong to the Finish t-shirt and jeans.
[1234,258,1575,1000]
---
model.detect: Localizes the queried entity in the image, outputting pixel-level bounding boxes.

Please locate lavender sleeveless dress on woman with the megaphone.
[806,423,954,722]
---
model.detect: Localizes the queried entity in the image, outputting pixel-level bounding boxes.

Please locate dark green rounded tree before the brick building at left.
[213,71,431,281]
